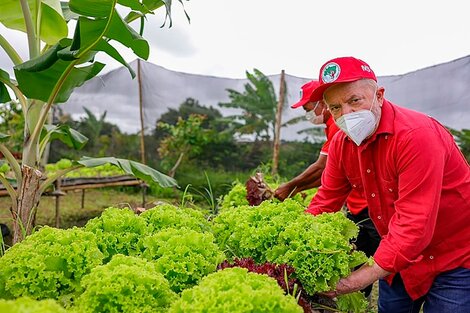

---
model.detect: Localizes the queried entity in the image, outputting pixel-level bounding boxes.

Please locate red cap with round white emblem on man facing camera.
[310,57,377,102]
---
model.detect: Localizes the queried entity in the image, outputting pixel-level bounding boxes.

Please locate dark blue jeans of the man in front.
[379,268,470,313]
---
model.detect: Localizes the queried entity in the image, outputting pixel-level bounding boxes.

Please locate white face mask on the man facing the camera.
[335,92,378,146]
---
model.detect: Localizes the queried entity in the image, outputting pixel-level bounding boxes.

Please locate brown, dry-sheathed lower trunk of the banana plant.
[11,165,42,244]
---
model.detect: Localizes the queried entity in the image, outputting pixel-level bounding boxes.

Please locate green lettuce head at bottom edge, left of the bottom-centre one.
[74,255,177,313]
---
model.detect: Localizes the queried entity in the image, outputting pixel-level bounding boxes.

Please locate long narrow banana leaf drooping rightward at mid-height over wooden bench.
[77,157,178,187]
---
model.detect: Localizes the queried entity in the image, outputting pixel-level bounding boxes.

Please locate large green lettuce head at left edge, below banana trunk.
[0,226,103,299]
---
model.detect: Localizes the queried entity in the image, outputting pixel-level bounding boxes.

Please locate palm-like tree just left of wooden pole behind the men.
[219,69,277,141]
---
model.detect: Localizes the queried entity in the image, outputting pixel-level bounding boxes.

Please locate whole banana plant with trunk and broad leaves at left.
[0,0,189,243]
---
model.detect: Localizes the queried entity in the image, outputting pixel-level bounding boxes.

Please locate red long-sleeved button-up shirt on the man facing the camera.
[307,100,470,299]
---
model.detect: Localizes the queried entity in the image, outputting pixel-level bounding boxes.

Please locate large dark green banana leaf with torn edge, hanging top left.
[15,0,153,103]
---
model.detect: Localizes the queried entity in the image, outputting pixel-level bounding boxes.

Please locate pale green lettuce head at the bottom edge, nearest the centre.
[169,267,303,313]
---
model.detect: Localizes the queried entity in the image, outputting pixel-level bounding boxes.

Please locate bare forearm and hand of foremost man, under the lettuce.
[323,264,390,298]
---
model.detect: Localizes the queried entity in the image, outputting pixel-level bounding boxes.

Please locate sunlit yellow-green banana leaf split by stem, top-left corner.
[0,0,68,45]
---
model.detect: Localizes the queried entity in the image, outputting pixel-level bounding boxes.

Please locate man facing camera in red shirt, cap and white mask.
[307,57,470,313]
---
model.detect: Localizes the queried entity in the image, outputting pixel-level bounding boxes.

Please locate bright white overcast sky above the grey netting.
[0,0,470,78]
